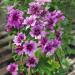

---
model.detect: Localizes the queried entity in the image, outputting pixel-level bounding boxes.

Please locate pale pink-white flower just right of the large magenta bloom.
[23,15,36,26]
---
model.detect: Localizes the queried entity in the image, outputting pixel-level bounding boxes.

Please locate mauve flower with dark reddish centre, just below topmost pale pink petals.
[28,2,42,15]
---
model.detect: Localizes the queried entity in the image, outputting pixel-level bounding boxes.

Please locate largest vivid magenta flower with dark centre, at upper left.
[7,9,23,29]
